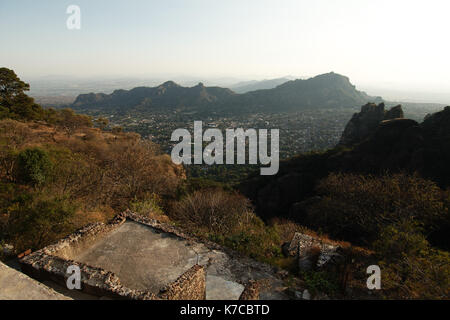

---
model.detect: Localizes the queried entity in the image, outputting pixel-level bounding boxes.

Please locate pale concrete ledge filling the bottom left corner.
[0,262,71,300]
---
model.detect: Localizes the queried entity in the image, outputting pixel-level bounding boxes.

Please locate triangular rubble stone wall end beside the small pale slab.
[159,264,206,300]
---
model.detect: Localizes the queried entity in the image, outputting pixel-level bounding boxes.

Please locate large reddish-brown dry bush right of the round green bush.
[48,129,183,210]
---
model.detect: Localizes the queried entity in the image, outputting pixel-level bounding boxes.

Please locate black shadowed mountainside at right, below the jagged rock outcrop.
[240,105,450,221]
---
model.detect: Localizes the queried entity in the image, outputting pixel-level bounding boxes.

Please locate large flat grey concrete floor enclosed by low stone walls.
[73,221,197,293]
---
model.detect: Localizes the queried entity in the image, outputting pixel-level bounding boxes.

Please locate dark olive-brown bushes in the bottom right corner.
[374,221,450,299]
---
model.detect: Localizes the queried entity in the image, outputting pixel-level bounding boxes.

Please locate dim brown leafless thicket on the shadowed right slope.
[307,174,448,245]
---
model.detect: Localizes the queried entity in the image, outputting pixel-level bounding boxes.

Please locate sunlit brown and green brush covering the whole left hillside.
[0,116,183,250]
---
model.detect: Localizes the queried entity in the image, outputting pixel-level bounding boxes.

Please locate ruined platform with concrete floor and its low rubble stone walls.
[18,212,288,300]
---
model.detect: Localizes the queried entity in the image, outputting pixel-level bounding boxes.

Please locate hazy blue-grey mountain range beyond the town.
[71,72,382,113]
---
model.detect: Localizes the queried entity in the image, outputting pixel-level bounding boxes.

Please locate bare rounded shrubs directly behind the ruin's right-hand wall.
[169,188,283,265]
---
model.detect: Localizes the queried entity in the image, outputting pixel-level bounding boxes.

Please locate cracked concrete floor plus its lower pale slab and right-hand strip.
[71,221,286,300]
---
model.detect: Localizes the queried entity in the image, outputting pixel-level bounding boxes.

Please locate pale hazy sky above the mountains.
[0,0,450,101]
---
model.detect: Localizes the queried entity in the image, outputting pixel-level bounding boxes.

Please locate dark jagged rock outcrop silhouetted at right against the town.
[340,103,404,146]
